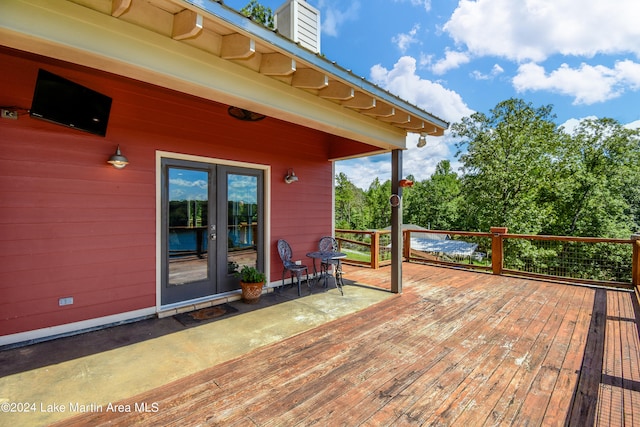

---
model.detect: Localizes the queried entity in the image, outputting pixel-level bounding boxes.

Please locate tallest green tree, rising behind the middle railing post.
[451,99,561,233]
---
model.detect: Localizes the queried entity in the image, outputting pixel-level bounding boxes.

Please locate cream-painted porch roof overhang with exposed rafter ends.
[0,0,448,160]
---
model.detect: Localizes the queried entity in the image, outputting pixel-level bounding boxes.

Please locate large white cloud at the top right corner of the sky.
[443,0,640,62]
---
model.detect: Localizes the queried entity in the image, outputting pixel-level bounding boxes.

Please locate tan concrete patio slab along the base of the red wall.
[0,286,393,427]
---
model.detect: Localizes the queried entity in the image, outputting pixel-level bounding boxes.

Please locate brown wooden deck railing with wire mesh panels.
[336,227,640,289]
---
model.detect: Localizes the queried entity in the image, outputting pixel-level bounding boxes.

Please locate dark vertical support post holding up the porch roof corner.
[391,149,402,294]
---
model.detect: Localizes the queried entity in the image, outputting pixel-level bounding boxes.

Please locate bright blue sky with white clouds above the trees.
[225,0,640,188]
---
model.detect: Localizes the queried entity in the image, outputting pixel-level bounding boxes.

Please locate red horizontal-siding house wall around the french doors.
[0,49,341,335]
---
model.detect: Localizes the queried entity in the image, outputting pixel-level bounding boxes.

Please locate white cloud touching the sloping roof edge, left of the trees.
[371,56,473,122]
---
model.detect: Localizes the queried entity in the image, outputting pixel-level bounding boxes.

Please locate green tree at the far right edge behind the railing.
[548,118,640,238]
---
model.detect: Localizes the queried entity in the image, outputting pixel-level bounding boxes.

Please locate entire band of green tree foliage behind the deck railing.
[336,99,640,241]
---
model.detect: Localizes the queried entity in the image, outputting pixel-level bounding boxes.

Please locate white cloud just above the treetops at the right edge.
[513,60,640,105]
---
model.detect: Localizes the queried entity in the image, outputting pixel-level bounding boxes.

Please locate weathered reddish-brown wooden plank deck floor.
[57,263,640,426]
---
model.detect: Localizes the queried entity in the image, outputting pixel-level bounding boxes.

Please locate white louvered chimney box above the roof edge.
[275,0,320,53]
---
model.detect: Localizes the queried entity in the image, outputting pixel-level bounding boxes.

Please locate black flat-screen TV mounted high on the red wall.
[29,69,111,136]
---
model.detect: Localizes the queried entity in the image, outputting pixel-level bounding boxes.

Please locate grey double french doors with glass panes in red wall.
[161,159,264,305]
